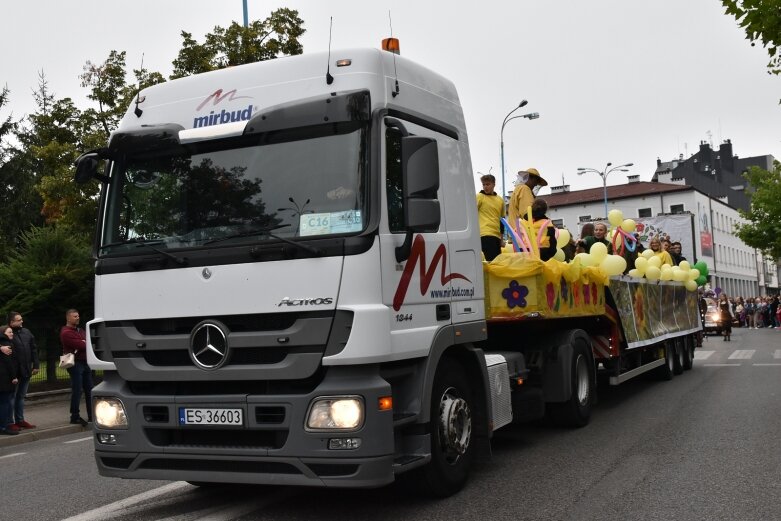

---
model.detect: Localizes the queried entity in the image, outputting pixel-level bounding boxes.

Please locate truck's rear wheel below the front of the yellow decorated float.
[546,342,596,427]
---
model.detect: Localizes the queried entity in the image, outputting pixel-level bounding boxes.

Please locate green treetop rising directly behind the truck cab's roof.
[171,8,305,79]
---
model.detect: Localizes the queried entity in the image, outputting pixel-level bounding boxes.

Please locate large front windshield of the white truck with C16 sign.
[100,123,367,255]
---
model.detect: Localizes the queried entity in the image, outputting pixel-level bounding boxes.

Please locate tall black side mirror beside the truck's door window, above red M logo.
[401,136,440,232]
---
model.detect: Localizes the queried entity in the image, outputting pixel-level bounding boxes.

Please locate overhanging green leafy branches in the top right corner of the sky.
[721,0,781,74]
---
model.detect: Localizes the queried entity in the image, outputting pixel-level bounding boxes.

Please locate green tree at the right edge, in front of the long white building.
[736,161,781,259]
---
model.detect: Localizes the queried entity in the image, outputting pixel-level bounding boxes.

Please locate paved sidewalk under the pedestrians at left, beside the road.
[0,389,91,448]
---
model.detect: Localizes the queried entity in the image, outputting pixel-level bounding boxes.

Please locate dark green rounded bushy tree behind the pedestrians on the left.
[0,226,94,378]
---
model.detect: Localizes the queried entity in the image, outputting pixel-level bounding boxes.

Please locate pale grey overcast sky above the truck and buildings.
[0,0,781,194]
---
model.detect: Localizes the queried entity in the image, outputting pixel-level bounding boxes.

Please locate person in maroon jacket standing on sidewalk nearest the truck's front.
[60,309,92,427]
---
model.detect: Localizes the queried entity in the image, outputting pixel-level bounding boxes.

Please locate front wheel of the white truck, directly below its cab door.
[410,358,475,497]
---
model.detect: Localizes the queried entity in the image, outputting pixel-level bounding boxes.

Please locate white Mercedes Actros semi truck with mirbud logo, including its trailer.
[76,42,699,496]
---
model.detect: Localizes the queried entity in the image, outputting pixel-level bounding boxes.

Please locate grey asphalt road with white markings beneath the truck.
[0,329,781,521]
